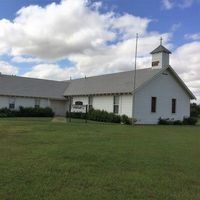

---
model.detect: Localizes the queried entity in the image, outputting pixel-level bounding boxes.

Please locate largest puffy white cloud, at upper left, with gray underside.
[0,0,159,60]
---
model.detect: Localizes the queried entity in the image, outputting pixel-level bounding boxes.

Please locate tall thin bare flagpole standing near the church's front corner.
[132,33,138,126]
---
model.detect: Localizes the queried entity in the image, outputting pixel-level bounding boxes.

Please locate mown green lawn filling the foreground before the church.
[0,119,200,200]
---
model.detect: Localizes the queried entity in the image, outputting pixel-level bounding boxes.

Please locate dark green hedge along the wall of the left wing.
[0,107,54,117]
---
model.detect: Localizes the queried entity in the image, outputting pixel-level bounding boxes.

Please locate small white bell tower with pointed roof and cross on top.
[151,37,171,69]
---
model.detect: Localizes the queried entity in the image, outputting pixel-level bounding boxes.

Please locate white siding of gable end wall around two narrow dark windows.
[134,69,190,124]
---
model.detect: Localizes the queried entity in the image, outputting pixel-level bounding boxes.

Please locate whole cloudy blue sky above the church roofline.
[0,0,200,100]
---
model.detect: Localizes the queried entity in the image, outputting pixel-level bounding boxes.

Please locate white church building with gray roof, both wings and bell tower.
[0,44,195,124]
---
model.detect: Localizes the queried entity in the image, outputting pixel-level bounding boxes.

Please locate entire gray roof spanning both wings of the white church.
[0,66,195,100]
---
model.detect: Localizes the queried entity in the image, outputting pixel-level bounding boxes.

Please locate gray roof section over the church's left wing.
[0,74,69,99]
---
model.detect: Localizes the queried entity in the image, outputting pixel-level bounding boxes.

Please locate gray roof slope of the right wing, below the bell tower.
[64,68,161,96]
